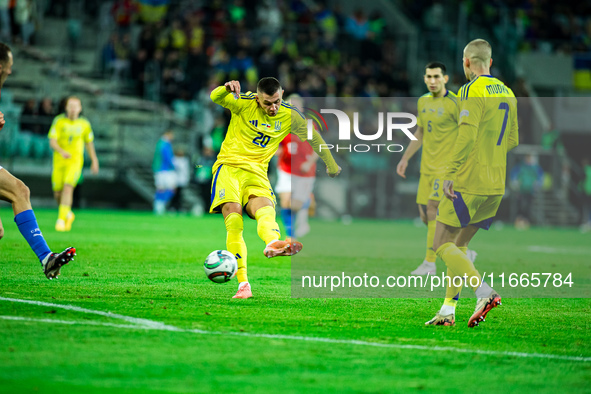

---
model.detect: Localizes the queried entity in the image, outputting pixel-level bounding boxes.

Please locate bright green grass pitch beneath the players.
[0,205,591,394]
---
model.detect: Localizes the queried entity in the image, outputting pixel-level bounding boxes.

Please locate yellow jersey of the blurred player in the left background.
[48,115,94,162]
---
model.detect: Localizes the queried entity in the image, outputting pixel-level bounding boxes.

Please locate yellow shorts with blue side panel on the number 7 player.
[437,192,503,230]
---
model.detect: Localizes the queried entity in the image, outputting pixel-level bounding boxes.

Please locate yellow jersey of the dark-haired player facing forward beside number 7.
[417,90,459,175]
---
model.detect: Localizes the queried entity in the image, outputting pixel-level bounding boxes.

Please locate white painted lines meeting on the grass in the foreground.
[0,297,591,362]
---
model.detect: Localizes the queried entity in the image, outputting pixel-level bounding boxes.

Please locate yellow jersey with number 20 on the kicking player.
[211,86,307,178]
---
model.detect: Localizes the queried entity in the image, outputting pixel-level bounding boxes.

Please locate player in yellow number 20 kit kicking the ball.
[210,77,341,298]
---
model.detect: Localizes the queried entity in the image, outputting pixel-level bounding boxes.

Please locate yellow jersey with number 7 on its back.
[445,75,519,196]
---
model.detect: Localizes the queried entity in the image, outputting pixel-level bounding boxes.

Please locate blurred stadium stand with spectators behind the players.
[0,0,591,225]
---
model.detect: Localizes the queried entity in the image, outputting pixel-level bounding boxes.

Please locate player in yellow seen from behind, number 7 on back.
[425,39,519,327]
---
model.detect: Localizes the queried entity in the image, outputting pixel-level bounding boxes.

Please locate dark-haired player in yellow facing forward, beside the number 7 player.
[396,62,476,275]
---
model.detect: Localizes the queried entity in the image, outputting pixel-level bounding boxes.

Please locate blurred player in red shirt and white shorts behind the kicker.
[275,94,318,238]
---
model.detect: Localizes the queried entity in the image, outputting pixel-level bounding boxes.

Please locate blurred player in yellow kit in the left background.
[48,96,99,231]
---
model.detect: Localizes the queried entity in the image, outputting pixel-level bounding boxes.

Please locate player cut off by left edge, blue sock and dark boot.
[0,43,76,279]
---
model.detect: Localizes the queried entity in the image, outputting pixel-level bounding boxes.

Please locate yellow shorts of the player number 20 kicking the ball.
[209,164,277,217]
